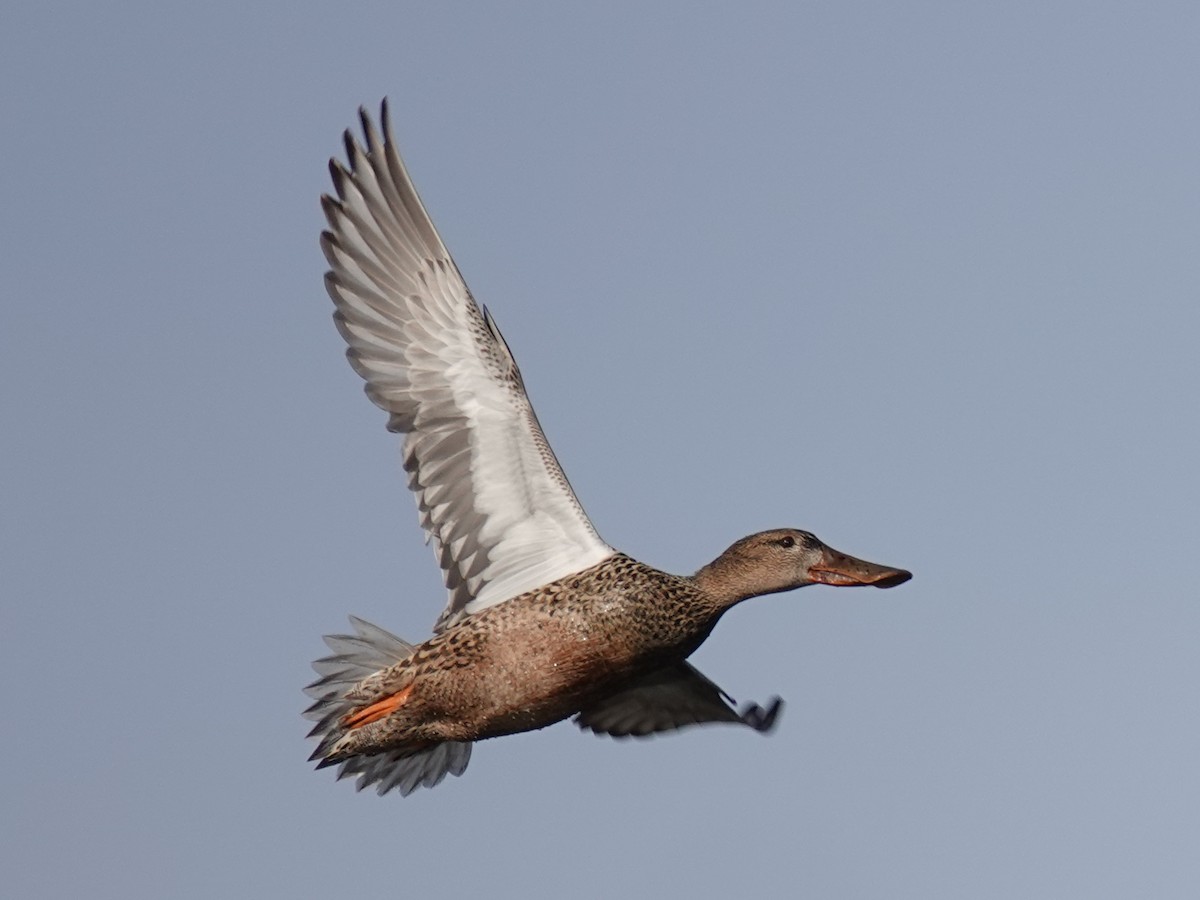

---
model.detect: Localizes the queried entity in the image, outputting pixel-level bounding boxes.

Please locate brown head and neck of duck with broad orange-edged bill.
[695,528,912,602]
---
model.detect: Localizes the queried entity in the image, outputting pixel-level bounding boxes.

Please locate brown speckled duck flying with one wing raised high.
[305,101,912,794]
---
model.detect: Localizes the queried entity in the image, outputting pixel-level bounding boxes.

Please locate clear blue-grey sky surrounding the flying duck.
[0,1,1200,900]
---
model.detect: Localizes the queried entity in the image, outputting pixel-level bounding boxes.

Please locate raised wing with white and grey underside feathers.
[320,101,613,631]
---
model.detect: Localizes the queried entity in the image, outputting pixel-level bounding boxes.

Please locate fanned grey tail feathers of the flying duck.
[304,616,470,797]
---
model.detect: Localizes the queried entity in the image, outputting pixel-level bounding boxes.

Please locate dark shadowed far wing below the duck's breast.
[575,662,784,738]
